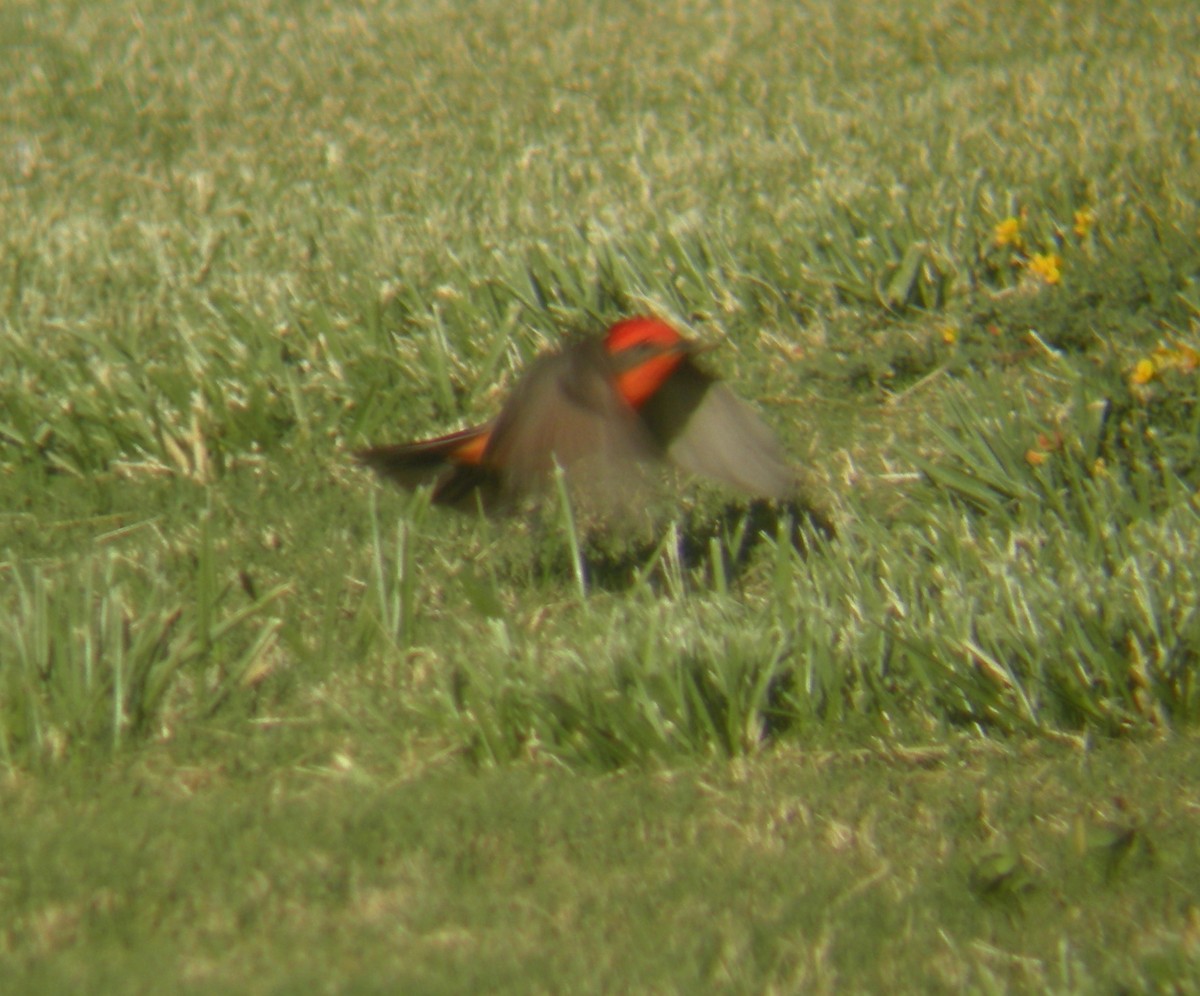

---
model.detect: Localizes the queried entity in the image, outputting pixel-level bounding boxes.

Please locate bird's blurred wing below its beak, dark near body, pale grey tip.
[641,360,797,498]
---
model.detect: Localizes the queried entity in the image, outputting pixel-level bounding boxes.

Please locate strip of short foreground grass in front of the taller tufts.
[0,730,1196,991]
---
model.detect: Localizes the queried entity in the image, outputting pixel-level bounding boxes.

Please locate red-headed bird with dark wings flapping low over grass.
[354,316,797,515]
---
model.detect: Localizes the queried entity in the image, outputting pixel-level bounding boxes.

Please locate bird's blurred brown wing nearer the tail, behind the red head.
[484,341,661,506]
